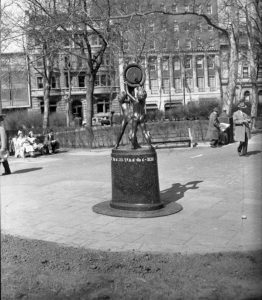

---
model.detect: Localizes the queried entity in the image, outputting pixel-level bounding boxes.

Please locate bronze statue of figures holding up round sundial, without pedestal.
[115,64,152,149]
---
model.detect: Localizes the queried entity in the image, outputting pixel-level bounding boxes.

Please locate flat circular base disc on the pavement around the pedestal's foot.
[92,201,183,218]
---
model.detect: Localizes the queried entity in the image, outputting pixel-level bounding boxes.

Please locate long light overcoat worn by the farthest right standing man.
[233,109,251,142]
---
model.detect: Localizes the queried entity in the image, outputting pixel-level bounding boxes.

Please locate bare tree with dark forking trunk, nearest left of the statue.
[22,0,114,126]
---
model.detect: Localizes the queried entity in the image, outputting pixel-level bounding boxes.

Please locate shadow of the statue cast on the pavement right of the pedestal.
[160,180,203,204]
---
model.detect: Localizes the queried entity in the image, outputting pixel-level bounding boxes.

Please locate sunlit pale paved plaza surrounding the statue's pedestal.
[0,134,262,253]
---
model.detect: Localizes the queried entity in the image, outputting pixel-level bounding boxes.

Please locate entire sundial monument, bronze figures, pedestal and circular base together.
[93,64,182,218]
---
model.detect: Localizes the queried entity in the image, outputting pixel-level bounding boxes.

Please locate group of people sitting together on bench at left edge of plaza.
[10,129,59,158]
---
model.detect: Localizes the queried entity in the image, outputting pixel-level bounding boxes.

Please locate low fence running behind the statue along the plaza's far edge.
[56,120,208,149]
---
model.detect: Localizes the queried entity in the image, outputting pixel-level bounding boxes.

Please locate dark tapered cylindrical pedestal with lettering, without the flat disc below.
[110,148,164,211]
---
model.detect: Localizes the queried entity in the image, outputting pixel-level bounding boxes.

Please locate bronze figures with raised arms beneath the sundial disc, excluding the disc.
[115,82,152,149]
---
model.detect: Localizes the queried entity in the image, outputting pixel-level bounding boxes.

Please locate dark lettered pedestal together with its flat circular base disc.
[93,147,182,218]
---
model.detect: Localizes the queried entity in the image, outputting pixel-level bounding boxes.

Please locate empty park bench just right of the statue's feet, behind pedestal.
[151,128,192,148]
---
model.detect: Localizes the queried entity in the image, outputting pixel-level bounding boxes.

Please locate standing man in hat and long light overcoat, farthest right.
[233,100,251,156]
